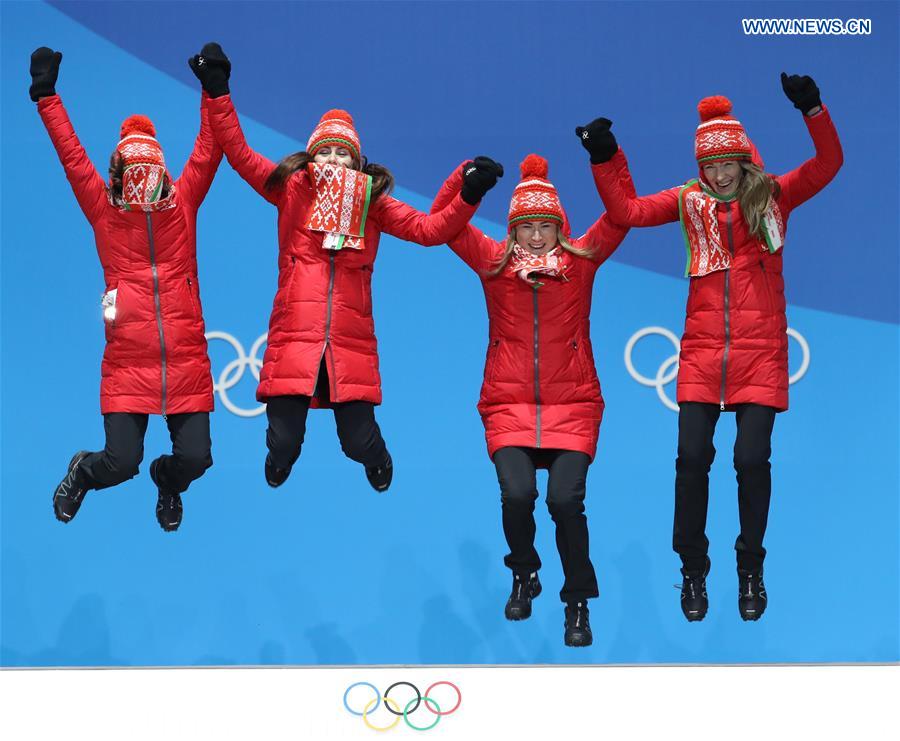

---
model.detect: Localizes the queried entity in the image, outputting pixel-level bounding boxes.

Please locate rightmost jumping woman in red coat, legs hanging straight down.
[578,74,843,621]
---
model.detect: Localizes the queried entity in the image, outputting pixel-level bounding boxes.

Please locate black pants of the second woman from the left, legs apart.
[266,362,388,469]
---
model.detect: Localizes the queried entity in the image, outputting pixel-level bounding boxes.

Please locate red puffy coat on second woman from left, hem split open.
[209,95,475,406]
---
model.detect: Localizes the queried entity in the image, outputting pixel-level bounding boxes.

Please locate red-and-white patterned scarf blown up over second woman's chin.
[306,163,372,250]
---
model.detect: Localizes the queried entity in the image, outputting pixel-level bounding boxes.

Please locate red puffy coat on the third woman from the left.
[433,158,634,460]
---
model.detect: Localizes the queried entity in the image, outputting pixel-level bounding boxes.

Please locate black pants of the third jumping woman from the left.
[494,447,598,602]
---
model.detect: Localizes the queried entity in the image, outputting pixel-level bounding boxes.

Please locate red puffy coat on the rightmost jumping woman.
[598,109,843,411]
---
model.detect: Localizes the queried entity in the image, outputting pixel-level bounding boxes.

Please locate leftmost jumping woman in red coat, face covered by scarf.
[30,47,222,531]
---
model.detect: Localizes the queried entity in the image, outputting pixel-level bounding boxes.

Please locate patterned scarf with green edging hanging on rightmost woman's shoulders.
[678,179,784,278]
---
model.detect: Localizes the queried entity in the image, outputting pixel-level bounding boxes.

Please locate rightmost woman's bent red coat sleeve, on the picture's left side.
[591,149,680,226]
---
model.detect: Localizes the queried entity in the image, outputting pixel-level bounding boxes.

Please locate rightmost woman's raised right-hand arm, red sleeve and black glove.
[776,73,844,211]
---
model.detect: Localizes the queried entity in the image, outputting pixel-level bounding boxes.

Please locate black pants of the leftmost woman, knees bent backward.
[78,412,212,494]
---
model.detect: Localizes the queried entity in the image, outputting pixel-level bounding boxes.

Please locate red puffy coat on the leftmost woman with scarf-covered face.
[38,95,222,414]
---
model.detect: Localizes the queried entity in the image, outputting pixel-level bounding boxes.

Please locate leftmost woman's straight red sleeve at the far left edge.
[38,95,109,225]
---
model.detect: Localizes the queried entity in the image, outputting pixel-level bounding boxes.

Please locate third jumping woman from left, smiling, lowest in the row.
[432,154,634,646]
